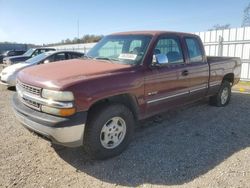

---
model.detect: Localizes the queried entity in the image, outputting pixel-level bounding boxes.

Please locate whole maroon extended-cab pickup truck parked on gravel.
[12,31,241,159]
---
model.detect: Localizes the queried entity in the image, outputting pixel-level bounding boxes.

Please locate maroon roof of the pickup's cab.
[111,30,196,36]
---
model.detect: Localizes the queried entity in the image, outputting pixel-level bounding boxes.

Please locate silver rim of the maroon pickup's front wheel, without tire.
[100,117,126,149]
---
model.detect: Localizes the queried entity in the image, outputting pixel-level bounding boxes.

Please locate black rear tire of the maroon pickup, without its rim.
[209,80,231,107]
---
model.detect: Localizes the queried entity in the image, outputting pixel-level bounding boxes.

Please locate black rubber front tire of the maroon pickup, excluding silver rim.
[83,104,135,159]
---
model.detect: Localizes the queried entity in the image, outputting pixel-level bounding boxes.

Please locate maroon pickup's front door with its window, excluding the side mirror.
[145,36,189,116]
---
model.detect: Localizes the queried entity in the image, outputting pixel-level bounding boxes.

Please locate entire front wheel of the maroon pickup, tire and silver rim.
[83,104,134,159]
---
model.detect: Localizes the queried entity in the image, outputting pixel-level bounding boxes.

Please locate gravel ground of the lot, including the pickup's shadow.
[0,81,250,187]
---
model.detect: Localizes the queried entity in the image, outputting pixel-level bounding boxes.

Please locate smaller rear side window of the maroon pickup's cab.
[185,37,203,63]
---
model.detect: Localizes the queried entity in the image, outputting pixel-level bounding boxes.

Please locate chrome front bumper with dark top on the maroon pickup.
[12,94,87,147]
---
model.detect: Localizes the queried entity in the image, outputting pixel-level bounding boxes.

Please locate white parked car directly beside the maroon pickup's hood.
[0,51,84,87]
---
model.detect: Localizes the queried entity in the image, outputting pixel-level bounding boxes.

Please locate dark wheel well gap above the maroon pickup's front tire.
[88,94,138,119]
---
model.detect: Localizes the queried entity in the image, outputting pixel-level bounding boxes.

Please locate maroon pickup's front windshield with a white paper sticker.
[87,35,152,65]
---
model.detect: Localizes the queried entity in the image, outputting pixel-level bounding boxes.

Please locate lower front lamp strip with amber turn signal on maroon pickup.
[41,106,76,116]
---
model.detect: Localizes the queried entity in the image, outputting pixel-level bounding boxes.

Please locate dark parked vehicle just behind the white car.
[3,48,56,67]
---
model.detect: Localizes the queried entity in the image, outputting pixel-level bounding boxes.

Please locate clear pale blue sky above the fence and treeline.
[0,0,250,44]
